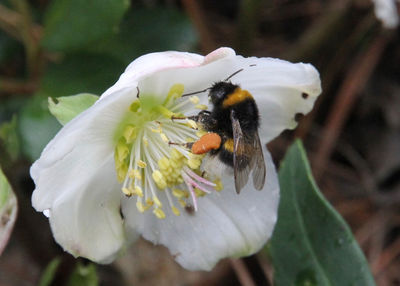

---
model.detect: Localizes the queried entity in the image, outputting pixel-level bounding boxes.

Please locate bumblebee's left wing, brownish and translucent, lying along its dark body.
[231,110,254,194]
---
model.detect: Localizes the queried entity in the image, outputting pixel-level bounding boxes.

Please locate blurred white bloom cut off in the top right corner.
[373,0,399,29]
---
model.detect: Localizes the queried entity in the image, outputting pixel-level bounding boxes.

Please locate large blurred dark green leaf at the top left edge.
[42,0,130,52]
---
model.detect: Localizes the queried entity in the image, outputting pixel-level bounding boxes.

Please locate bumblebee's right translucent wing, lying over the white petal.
[251,132,267,191]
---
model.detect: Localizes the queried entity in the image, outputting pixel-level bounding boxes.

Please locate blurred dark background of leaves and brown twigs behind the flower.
[0,0,400,286]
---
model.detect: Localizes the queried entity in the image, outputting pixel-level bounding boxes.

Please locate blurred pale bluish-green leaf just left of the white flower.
[18,94,61,161]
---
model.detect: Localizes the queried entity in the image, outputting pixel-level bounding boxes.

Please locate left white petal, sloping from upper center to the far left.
[31,86,136,211]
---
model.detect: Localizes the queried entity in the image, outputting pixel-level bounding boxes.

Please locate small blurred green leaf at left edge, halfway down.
[0,115,19,160]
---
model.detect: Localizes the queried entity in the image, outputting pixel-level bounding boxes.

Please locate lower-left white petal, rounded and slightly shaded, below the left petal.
[50,158,125,263]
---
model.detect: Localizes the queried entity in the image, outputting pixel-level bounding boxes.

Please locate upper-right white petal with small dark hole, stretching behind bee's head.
[139,54,321,136]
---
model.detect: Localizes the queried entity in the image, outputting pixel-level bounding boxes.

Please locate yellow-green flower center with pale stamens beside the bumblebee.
[114,84,222,219]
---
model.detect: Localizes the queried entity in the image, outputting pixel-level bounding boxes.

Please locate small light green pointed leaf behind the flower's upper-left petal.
[49,93,99,125]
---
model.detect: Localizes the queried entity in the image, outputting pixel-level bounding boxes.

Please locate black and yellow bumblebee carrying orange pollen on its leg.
[191,79,266,194]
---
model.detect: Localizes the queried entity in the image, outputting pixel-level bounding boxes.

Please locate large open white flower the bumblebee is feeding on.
[31,48,321,270]
